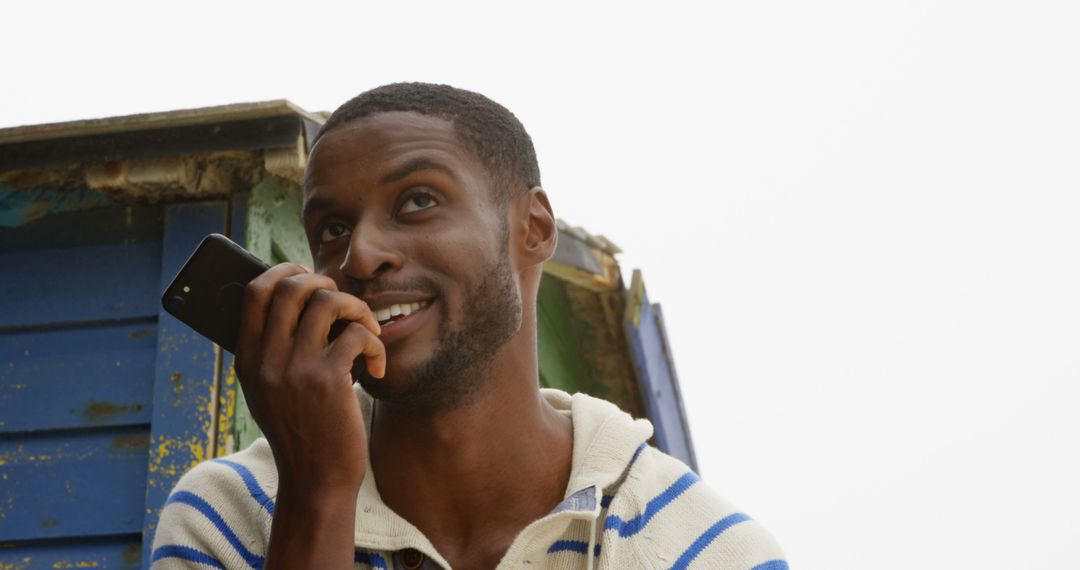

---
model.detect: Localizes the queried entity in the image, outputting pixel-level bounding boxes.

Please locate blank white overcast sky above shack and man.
[0,0,1080,569]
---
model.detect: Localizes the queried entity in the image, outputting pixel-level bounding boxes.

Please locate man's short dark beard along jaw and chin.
[353,247,522,416]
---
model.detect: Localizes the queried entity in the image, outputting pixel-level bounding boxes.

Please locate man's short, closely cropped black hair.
[312,83,540,205]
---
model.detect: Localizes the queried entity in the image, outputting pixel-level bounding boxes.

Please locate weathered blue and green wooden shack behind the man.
[0,100,696,570]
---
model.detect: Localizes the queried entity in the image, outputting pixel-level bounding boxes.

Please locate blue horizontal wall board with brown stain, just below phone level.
[0,320,157,434]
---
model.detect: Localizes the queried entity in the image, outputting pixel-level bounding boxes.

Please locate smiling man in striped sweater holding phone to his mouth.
[152,83,787,570]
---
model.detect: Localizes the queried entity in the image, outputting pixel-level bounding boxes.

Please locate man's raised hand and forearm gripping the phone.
[237,263,387,568]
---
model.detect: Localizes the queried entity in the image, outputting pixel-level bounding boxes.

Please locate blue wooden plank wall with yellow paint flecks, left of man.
[0,194,229,569]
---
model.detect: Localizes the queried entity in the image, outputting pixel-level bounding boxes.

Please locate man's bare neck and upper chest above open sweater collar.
[370,351,572,567]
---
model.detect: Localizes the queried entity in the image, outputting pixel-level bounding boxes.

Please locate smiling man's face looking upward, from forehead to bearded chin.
[303,112,522,412]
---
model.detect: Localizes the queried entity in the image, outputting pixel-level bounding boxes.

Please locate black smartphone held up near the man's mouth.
[161,233,270,352]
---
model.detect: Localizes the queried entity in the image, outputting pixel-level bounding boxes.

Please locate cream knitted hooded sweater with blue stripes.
[152,390,787,570]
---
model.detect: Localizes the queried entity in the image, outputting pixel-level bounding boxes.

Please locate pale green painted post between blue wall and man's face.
[226,176,312,449]
